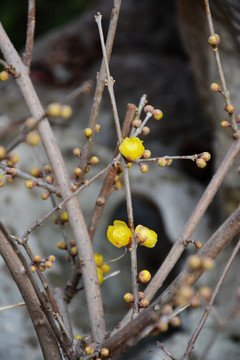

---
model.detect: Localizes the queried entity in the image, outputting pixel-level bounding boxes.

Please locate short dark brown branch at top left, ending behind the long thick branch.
[23,0,35,69]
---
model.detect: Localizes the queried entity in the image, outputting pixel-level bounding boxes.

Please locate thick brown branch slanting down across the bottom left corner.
[0,225,62,360]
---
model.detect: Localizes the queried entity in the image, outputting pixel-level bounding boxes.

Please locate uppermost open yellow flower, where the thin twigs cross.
[119,137,145,161]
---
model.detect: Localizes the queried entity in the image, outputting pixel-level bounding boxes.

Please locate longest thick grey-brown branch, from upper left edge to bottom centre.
[0,24,106,342]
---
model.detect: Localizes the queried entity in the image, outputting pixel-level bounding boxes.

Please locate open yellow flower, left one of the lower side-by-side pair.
[107,220,132,248]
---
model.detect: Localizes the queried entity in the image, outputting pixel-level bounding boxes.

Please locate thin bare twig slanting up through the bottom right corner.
[183,239,240,360]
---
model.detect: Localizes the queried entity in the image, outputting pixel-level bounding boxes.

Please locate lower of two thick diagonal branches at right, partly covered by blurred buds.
[102,207,240,354]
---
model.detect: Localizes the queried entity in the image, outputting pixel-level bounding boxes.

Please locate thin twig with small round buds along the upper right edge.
[204,0,239,136]
